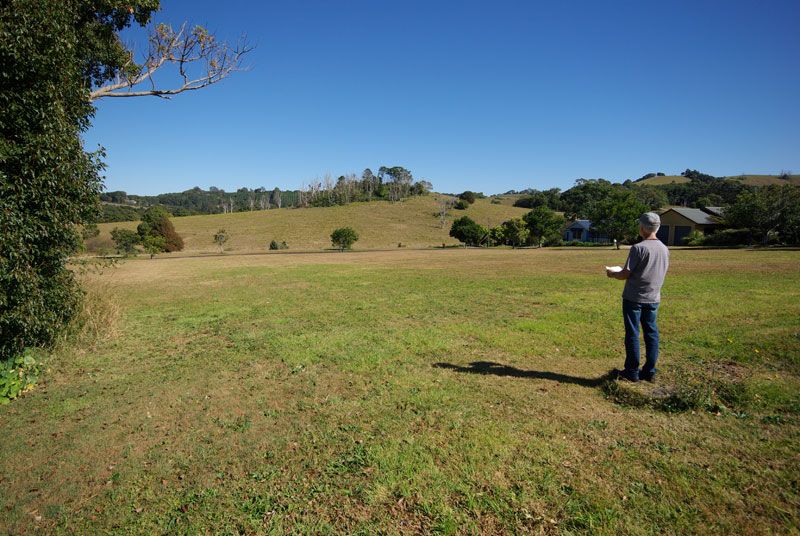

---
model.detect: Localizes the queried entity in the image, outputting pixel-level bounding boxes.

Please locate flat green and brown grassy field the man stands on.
[0,248,800,535]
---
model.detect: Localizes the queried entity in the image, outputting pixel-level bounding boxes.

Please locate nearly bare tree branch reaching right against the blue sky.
[89,23,255,101]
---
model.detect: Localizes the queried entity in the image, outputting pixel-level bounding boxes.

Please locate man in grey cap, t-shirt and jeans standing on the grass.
[606,212,669,382]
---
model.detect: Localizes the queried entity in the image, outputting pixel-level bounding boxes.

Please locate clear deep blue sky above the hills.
[85,0,800,194]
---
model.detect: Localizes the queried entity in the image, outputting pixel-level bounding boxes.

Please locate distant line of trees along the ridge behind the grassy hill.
[99,166,432,223]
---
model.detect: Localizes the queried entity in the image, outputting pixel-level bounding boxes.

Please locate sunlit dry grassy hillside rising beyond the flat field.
[87,195,527,254]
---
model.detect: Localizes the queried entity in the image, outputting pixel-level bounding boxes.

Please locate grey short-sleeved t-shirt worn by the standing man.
[622,240,669,303]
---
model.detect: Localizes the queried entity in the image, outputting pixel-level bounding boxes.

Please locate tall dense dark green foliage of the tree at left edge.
[0,0,158,359]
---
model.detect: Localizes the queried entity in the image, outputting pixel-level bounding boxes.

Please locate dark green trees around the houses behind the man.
[494,169,800,246]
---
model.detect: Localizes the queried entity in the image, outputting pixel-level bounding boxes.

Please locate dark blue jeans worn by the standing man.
[622,300,658,380]
